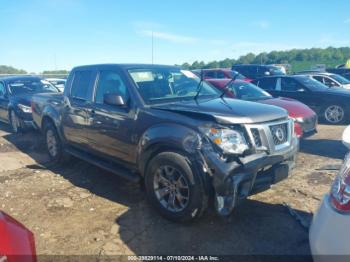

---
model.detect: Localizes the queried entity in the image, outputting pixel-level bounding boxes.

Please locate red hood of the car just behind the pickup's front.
[259,97,316,118]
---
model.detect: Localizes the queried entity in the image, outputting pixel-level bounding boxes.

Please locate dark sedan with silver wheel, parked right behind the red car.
[253,75,350,124]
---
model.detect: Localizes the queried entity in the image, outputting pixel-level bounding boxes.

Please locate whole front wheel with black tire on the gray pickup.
[145,152,208,222]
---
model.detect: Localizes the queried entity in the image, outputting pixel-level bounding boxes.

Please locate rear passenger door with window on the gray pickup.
[62,70,96,149]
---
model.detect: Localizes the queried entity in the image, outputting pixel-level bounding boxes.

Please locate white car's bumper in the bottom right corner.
[309,194,350,261]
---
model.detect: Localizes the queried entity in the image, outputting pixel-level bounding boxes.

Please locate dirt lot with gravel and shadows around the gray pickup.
[0,124,346,260]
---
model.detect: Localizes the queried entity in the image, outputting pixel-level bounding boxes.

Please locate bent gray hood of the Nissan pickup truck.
[152,98,288,124]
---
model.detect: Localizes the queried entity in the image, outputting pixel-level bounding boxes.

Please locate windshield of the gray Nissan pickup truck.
[129,67,220,104]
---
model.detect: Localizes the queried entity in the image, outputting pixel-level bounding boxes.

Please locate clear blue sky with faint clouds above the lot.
[0,0,350,72]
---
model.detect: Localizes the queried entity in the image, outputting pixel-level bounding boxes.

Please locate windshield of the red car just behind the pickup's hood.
[228,81,272,101]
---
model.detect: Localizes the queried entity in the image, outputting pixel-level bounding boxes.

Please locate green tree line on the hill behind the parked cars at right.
[181,47,350,72]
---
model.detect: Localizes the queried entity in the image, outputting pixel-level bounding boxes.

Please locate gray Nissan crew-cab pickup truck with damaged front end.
[32,64,298,221]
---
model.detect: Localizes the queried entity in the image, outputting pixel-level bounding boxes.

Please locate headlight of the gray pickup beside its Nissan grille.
[201,128,249,154]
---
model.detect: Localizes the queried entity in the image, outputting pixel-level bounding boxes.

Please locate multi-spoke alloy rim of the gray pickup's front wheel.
[153,166,190,212]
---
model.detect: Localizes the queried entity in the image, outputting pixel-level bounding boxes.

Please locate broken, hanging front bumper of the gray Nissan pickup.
[203,137,299,215]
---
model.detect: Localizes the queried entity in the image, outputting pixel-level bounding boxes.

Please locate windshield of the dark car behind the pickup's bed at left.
[8,80,58,95]
